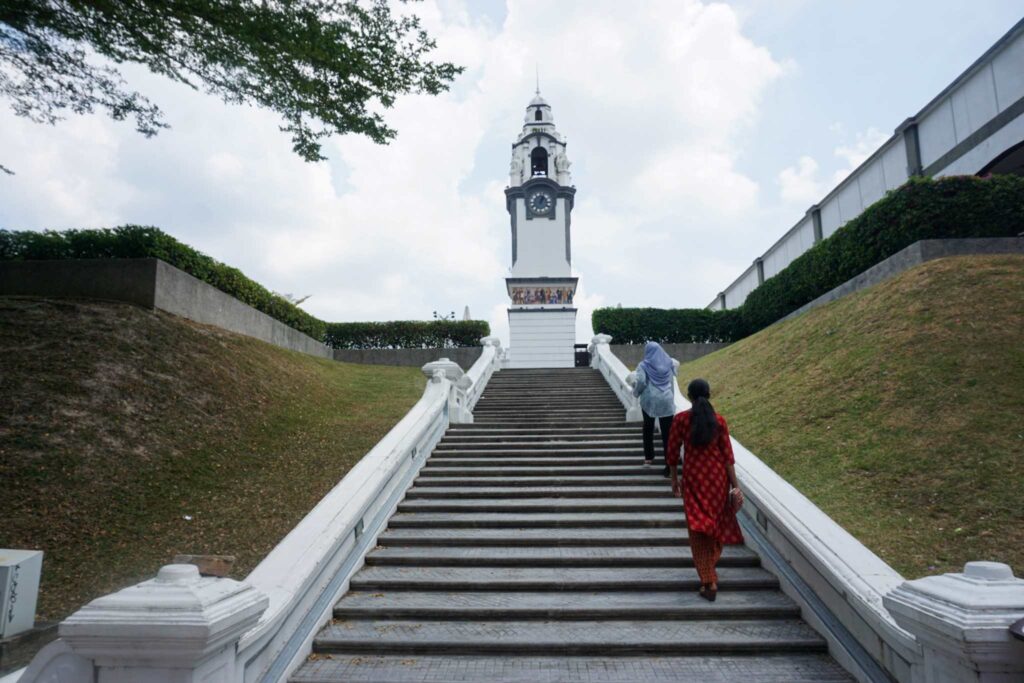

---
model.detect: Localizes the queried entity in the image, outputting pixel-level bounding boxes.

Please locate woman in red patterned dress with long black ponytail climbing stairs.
[666,380,743,601]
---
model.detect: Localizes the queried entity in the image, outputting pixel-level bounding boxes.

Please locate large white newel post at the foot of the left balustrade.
[59,564,268,683]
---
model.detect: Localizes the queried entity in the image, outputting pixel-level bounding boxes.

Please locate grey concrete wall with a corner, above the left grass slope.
[0,258,331,358]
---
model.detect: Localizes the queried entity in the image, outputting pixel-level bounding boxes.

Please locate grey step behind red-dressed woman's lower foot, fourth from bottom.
[350,566,778,593]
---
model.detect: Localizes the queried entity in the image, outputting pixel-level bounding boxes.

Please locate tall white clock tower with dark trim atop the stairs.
[505,91,577,368]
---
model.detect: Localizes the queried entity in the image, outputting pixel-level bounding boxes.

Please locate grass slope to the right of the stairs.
[679,256,1024,578]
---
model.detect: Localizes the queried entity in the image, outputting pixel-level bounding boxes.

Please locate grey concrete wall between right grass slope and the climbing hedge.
[782,238,1024,323]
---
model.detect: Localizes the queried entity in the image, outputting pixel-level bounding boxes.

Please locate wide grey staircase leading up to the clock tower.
[292,370,851,683]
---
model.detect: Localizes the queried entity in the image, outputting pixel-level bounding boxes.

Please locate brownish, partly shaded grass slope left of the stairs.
[0,298,424,620]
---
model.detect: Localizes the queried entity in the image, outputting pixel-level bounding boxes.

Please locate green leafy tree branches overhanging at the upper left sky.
[0,0,462,161]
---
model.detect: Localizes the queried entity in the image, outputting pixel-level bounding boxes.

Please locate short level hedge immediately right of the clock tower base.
[592,308,743,344]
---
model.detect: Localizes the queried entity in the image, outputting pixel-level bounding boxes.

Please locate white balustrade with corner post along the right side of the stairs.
[591,335,1024,683]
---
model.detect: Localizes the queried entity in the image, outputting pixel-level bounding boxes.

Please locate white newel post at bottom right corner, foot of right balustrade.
[883,562,1024,683]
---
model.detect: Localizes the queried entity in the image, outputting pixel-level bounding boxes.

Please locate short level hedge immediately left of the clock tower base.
[324,321,490,348]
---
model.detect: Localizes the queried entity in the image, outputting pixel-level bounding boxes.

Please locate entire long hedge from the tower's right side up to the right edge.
[593,175,1024,344]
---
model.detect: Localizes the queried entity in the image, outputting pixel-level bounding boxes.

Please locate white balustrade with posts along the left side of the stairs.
[9,344,501,683]
